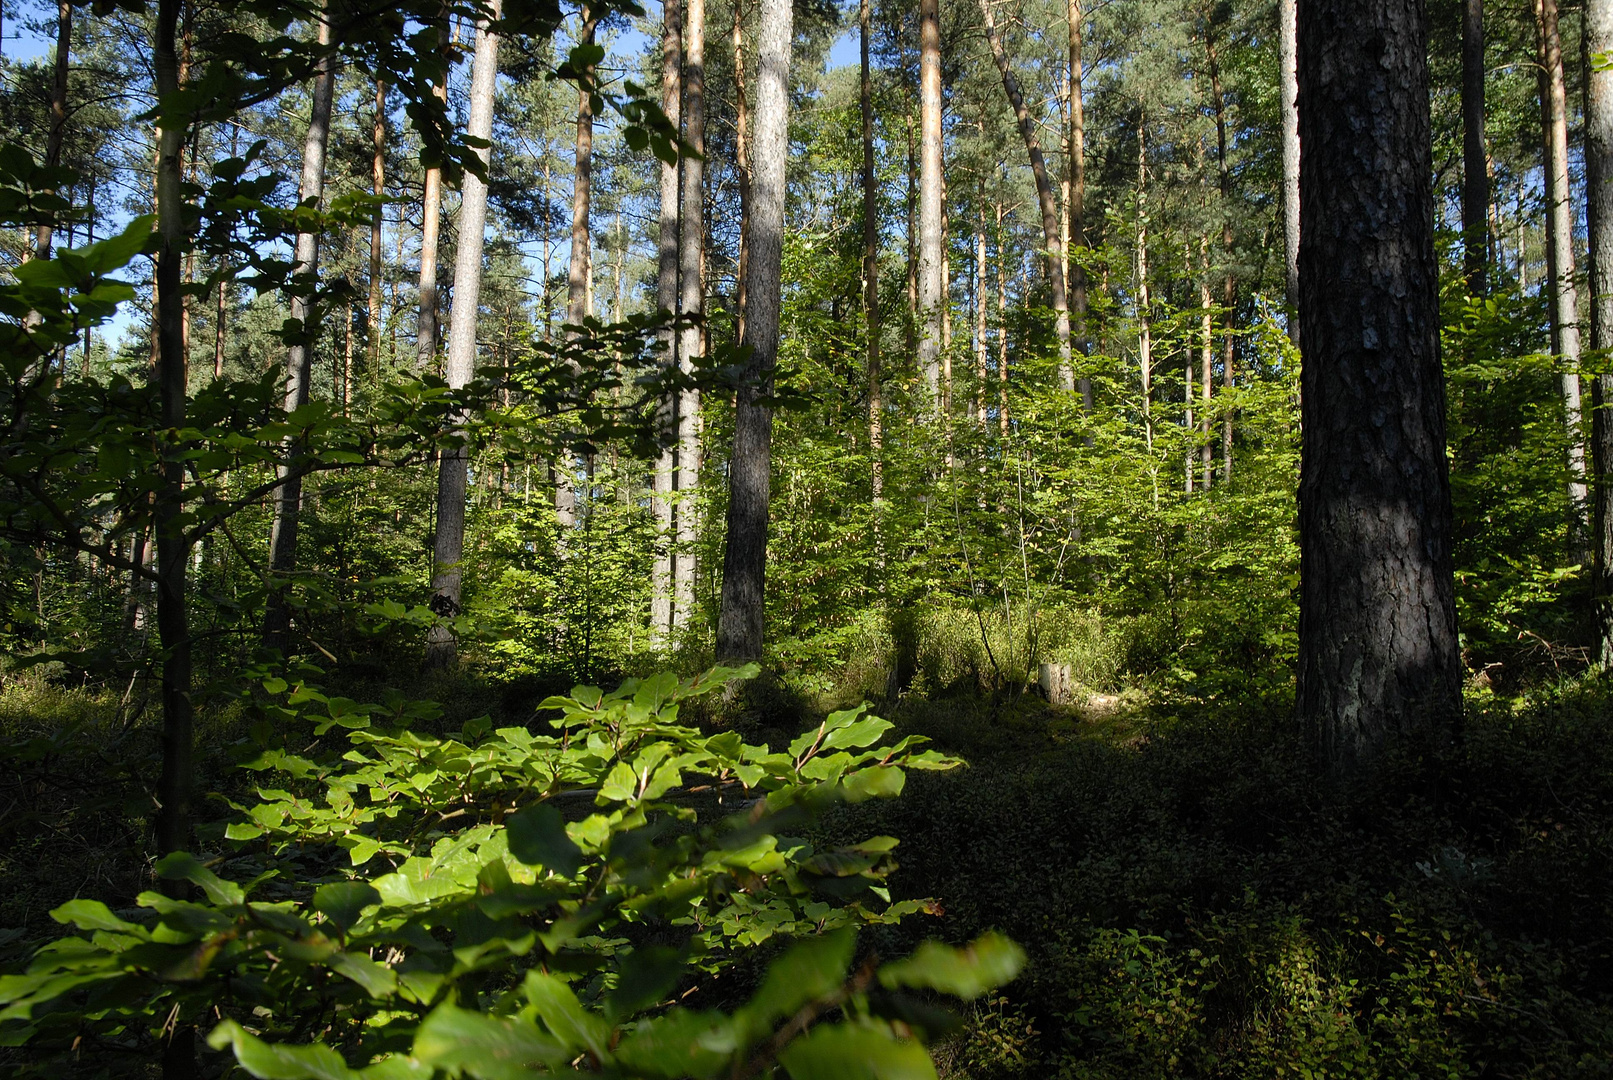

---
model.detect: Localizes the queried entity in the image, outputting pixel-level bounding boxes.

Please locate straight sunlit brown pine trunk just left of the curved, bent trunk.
[918,0,945,409]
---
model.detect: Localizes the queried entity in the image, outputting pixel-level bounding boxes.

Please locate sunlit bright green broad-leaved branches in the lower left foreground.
[0,669,1021,1080]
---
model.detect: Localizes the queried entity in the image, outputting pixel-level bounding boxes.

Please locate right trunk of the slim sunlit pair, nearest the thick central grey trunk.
[673,0,705,633]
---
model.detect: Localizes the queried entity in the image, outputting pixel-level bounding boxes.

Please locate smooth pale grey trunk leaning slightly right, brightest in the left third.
[426,0,503,667]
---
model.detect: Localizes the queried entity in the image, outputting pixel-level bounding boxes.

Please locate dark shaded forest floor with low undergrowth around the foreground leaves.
[0,680,1613,1080]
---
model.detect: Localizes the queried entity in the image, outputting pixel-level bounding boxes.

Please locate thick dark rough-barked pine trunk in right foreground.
[1297,0,1461,771]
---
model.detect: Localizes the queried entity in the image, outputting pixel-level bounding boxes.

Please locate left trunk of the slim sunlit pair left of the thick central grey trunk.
[650,0,683,648]
